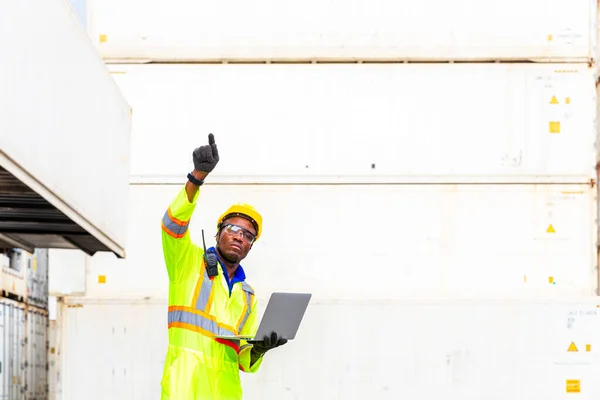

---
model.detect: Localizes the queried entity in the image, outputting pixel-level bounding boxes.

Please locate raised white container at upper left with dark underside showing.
[0,0,130,256]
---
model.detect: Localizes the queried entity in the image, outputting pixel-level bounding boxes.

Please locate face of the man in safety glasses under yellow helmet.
[219,217,256,264]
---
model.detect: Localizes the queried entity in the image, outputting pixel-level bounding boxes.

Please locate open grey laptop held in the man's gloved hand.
[215,292,312,340]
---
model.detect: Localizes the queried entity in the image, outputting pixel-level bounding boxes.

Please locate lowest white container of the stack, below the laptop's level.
[60,298,600,400]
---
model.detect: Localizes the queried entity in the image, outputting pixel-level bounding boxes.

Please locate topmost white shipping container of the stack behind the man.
[87,0,596,62]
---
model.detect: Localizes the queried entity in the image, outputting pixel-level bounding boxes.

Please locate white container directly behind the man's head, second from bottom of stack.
[61,181,598,300]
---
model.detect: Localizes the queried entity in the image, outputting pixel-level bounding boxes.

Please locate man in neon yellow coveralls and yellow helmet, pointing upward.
[161,133,287,400]
